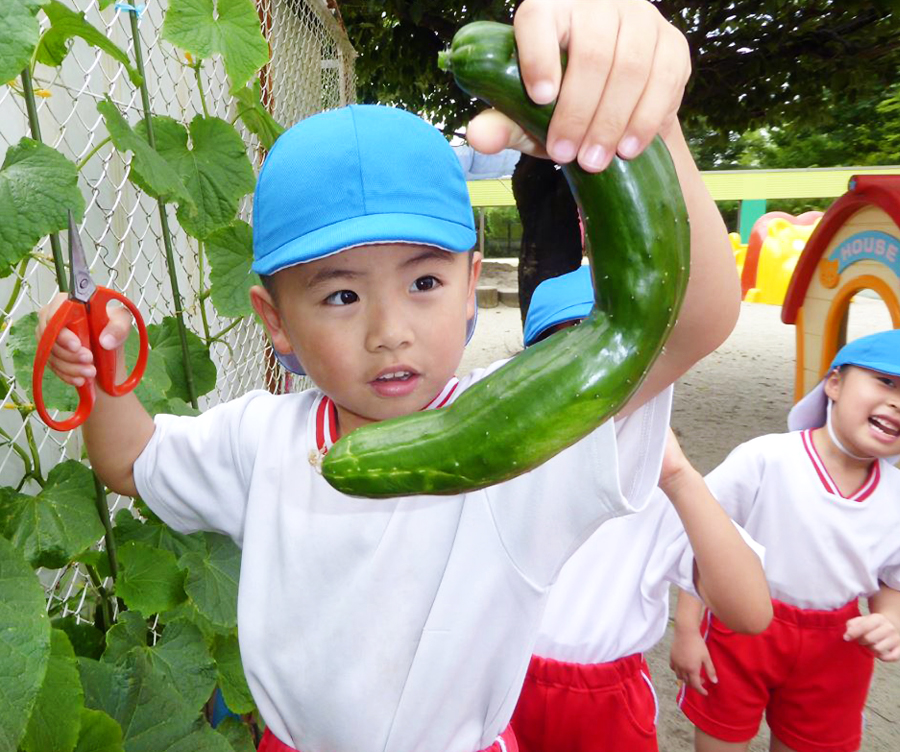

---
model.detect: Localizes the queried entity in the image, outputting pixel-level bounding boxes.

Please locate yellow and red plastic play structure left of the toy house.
[732,211,822,305]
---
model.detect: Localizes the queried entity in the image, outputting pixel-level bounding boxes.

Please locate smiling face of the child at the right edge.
[825,366,900,457]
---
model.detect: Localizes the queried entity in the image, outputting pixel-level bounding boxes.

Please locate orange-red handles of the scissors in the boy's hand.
[31,287,149,431]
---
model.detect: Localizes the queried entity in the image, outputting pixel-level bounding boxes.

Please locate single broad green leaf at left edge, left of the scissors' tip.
[0,138,84,277]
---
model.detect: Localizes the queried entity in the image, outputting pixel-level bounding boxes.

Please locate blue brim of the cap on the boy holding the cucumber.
[253,214,477,275]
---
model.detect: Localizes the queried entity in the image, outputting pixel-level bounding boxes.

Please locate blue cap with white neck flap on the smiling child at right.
[788,329,900,431]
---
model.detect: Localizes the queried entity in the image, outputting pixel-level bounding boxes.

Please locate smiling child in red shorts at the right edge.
[672,330,900,752]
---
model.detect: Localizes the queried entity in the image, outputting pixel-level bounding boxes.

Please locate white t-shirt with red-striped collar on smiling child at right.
[706,431,900,610]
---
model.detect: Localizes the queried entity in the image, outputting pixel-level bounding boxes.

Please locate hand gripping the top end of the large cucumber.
[467,0,691,172]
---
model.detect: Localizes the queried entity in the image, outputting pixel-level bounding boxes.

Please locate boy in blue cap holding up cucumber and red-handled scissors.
[41,0,738,752]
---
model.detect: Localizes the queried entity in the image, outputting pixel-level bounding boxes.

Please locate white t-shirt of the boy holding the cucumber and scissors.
[134,362,664,752]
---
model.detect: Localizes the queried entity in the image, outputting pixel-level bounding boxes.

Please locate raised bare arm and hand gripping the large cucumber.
[466,0,740,414]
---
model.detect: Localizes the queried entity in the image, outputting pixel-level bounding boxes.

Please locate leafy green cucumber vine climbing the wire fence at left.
[0,0,282,752]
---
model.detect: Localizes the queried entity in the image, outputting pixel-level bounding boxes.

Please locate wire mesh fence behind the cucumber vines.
[0,0,355,618]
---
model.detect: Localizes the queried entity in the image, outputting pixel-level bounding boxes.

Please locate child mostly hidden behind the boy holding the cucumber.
[512,266,772,752]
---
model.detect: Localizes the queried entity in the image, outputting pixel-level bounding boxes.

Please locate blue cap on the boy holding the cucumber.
[253,105,476,274]
